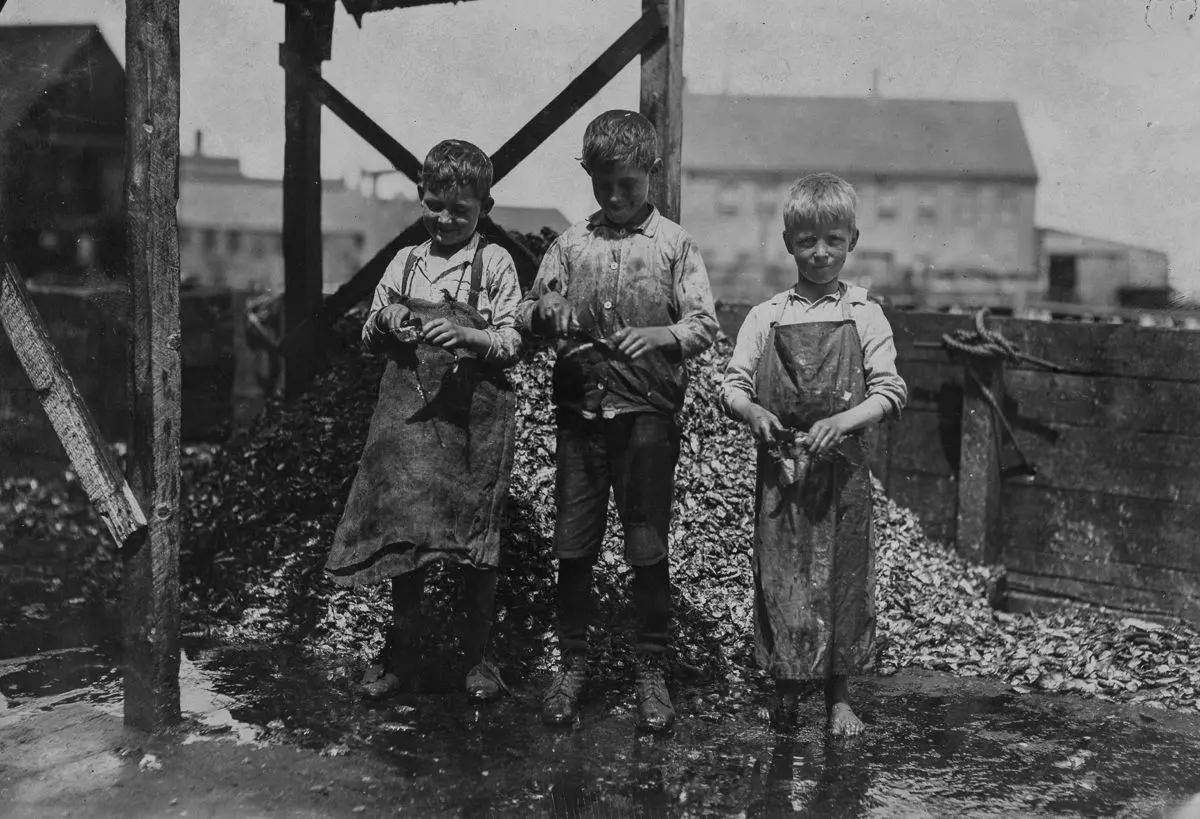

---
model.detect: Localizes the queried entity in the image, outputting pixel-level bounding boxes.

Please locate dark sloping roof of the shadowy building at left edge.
[0,25,116,133]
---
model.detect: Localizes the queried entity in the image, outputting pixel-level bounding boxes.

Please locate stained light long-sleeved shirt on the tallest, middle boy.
[520,207,719,418]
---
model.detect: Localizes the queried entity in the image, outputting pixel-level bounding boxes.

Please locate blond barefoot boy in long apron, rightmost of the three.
[722,174,907,735]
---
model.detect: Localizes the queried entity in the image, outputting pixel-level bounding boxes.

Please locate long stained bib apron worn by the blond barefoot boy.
[754,294,875,680]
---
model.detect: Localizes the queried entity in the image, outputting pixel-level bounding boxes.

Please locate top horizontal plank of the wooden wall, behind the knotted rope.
[887,310,1200,383]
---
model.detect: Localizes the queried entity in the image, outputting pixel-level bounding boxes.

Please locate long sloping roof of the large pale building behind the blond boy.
[683,94,1037,181]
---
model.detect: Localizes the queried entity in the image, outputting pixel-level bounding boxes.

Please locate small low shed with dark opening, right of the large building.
[1038,228,1171,309]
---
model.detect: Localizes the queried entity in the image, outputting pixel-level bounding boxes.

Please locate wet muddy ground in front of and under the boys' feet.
[0,542,1200,817]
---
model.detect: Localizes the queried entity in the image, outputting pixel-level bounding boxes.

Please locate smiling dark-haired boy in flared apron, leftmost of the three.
[325,139,521,700]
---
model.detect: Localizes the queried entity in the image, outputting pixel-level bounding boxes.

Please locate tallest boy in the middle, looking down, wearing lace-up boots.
[518,110,718,730]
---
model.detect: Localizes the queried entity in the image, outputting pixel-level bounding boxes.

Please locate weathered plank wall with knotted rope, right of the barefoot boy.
[721,306,1200,623]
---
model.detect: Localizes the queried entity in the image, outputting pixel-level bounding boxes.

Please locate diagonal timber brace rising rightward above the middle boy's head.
[492,0,678,184]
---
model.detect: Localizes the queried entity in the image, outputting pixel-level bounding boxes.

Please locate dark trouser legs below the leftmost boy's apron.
[388,567,496,671]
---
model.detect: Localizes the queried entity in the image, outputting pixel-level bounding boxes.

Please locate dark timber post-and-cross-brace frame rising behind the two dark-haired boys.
[275,0,684,396]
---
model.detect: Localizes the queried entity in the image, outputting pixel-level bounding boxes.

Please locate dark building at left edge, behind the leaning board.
[0,25,125,283]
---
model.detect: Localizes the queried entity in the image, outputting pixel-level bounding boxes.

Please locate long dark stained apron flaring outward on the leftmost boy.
[325,238,516,586]
